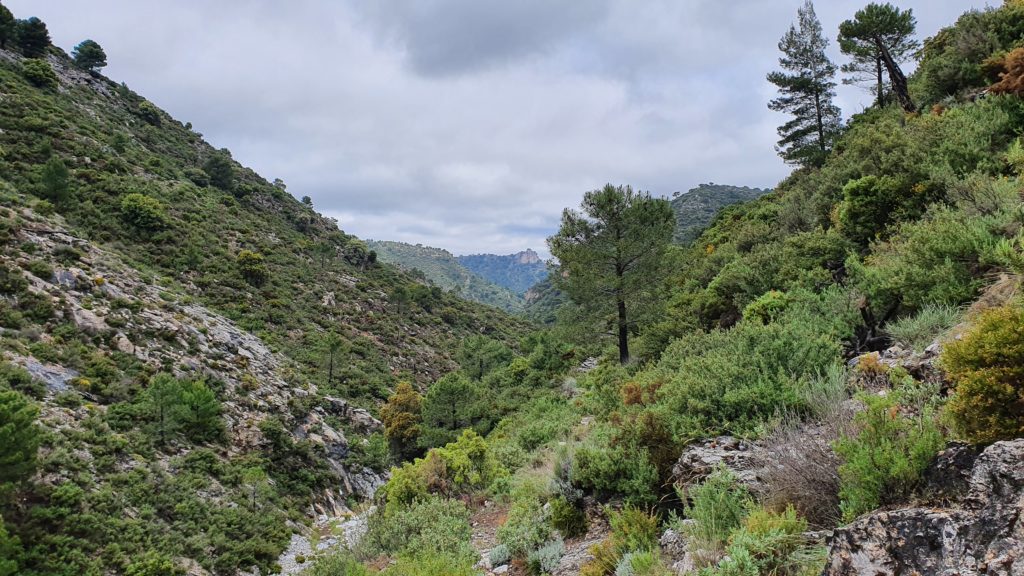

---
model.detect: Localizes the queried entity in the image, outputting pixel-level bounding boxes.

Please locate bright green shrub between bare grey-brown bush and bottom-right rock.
[836,395,944,521]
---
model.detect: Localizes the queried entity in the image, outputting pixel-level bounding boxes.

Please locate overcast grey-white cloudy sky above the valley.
[12,0,998,255]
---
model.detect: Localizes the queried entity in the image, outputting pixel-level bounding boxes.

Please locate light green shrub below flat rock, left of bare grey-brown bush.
[680,466,753,558]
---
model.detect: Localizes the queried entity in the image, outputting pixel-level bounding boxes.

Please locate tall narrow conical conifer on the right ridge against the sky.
[768,0,841,166]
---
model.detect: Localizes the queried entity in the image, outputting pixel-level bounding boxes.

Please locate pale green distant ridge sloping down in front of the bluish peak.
[367,240,524,313]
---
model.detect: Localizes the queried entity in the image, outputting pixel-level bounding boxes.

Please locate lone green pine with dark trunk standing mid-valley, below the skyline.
[548,184,676,364]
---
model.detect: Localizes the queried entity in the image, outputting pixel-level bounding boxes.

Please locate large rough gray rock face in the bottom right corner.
[823,439,1024,576]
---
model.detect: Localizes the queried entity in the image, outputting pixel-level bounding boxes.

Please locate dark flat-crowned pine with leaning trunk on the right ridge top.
[839,2,920,112]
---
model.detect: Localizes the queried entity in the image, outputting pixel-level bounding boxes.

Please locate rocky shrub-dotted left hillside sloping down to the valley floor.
[0,35,525,575]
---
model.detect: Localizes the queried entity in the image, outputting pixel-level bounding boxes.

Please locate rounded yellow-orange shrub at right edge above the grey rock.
[941,304,1024,444]
